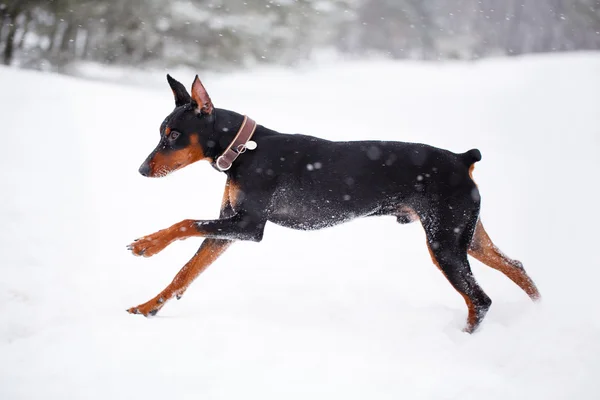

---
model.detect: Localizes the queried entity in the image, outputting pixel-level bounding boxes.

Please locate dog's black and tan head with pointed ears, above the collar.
[139,75,215,177]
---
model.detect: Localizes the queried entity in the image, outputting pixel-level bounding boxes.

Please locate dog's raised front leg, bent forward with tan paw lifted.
[127,211,265,257]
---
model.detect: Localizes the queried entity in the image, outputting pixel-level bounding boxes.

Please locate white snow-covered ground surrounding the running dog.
[0,54,600,400]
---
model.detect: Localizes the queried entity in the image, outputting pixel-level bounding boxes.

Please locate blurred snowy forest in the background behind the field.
[0,0,600,70]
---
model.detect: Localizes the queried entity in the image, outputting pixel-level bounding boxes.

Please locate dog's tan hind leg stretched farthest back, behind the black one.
[469,220,540,300]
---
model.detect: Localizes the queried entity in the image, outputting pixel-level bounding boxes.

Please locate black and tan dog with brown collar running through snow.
[128,76,539,332]
